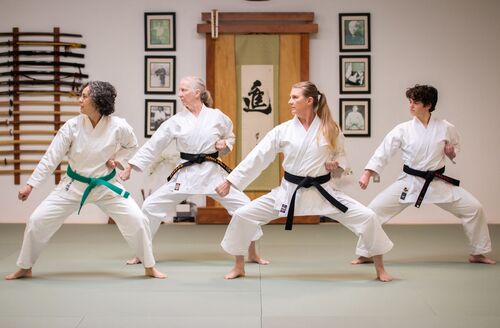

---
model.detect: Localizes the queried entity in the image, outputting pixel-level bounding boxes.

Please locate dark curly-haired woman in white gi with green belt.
[5,81,165,280]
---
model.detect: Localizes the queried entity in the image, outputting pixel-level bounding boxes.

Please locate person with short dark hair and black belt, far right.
[352,85,496,264]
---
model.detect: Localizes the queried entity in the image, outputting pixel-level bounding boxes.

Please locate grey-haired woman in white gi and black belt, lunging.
[120,77,269,264]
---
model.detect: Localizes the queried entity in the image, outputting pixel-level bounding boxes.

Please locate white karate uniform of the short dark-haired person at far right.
[365,116,491,255]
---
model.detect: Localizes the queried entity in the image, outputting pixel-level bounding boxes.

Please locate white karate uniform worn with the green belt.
[17,114,155,269]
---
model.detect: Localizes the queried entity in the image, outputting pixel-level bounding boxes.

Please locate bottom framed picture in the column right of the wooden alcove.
[339,98,371,137]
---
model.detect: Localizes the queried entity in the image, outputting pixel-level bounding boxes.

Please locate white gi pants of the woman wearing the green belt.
[17,187,155,269]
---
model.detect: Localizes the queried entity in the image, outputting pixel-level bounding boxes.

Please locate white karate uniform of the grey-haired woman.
[129,106,254,237]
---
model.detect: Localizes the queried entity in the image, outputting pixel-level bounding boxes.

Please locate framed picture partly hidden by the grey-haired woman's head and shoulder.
[144,99,176,138]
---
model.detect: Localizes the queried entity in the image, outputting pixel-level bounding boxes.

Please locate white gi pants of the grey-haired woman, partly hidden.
[142,184,262,240]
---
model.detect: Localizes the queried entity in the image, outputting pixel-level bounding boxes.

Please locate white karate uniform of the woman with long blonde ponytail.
[221,116,393,257]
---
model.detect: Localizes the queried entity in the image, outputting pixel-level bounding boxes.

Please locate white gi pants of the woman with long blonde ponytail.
[221,192,393,257]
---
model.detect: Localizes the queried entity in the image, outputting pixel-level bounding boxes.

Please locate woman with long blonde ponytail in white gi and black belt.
[216,82,393,281]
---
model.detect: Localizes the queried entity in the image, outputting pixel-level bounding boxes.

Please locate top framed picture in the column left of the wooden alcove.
[144,13,175,51]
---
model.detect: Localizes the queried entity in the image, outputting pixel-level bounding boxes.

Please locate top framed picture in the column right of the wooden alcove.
[339,13,370,52]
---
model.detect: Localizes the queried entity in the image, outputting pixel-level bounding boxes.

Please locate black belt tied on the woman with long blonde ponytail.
[285,172,348,230]
